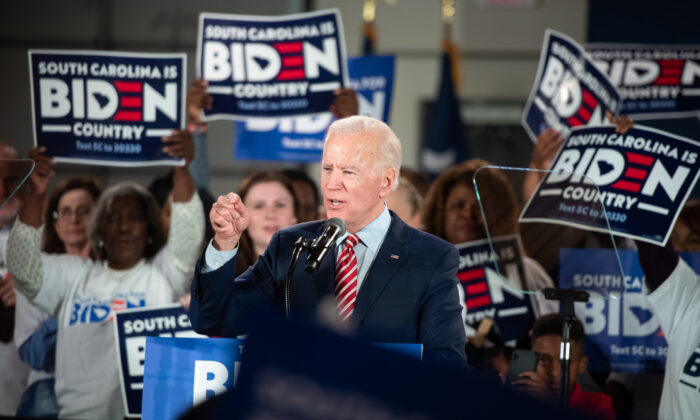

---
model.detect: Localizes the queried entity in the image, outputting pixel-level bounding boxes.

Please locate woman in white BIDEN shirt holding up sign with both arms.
[8,130,204,419]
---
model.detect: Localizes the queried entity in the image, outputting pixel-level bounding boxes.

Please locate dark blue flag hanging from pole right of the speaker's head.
[421,46,470,176]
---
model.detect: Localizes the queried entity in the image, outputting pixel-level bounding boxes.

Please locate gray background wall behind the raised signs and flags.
[0,0,588,194]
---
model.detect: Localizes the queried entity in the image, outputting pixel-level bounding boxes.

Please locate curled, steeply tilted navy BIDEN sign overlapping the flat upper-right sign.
[522,29,622,141]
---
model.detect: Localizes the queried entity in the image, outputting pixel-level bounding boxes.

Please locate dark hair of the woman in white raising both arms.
[88,182,165,261]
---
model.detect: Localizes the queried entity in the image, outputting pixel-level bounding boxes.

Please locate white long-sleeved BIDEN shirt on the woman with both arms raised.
[8,194,204,419]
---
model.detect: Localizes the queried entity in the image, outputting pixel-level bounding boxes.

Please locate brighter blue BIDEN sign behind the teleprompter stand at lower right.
[559,248,668,373]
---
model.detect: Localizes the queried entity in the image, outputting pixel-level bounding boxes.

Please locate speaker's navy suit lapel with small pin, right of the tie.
[351,213,410,325]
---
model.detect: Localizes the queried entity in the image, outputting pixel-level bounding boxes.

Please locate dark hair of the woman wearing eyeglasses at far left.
[42,177,102,254]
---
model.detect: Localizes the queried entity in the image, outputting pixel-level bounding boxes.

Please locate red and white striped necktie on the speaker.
[335,233,360,322]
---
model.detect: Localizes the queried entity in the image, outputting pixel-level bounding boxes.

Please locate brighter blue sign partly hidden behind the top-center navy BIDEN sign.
[234,55,394,162]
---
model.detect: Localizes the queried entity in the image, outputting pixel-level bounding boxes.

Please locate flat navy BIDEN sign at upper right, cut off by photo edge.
[586,44,700,120]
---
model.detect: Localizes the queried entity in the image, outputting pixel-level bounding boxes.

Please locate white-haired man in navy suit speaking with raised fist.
[190,116,466,368]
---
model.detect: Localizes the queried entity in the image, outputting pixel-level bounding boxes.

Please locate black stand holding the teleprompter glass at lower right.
[544,287,589,409]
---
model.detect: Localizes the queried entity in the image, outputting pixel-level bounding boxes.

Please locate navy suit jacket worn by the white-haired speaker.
[190,212,466,368]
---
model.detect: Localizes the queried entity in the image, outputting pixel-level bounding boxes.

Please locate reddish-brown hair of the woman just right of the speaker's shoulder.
[423,159,519,240]
